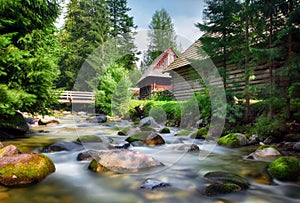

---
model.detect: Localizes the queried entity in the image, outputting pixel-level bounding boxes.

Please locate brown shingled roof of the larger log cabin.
[163,40,205,72]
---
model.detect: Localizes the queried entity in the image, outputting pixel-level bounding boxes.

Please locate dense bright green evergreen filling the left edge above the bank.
[0,0,60,115]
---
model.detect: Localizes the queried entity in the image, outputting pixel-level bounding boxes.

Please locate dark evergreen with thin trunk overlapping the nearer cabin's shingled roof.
[196,0,241,89]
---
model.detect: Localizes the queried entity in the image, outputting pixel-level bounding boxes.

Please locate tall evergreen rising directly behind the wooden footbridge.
[58,0,110,89]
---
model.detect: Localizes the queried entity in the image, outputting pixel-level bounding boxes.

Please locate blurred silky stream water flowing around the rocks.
[0,116,300,203]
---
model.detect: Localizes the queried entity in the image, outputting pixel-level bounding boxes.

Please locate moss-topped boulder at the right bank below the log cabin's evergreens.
[218,133,248,147]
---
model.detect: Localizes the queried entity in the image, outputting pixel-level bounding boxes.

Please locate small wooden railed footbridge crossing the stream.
[58,91,95,104]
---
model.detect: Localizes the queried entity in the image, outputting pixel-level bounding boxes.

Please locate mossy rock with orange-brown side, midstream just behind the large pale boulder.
[125,131,165,146]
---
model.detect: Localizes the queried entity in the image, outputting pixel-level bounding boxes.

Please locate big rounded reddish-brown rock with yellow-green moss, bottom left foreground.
[0,154,55,186]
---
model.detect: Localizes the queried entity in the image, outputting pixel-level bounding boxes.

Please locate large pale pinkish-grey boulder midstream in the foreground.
[89,149,163,173]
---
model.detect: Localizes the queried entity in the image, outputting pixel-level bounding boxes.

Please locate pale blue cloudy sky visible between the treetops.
[56,0,204,51]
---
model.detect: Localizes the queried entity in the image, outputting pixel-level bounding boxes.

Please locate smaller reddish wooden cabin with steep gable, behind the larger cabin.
[137,48,178,99]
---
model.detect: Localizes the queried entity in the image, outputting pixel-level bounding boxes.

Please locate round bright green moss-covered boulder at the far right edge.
[269,157,300,181]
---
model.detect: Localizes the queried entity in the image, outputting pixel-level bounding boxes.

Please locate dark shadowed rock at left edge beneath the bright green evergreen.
[0,112,29,140]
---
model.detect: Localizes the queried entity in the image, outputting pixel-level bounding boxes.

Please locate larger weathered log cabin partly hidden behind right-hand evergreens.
[164,40,282,100]
